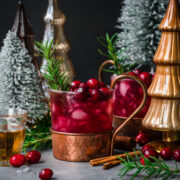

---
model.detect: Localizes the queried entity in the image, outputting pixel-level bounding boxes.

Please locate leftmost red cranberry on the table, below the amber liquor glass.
[9,154,26,167]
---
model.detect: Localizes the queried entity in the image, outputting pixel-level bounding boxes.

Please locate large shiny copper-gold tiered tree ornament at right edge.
[142,0,180,151]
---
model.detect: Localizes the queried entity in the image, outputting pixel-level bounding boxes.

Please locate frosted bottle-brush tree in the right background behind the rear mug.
[117,0,169,70]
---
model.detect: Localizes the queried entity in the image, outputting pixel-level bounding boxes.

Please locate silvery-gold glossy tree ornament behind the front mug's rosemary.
[41,0,75,98]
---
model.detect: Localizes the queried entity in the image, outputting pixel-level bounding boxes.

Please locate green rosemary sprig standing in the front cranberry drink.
[35,40,71,91]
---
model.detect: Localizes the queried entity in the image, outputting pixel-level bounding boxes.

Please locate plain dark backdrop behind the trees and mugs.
[0,0,121,81]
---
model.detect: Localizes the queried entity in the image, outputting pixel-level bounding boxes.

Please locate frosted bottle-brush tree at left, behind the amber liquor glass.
[0,31,48,122]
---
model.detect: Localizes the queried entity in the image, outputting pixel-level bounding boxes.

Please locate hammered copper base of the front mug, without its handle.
[51,130,112,162]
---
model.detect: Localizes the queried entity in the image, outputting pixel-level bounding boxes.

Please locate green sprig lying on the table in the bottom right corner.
[117,152,180,180]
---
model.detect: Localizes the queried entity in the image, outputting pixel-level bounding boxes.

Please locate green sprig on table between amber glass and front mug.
[23,113,52,152]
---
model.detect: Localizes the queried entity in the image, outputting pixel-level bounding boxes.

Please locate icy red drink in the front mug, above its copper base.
[50,90,112,133]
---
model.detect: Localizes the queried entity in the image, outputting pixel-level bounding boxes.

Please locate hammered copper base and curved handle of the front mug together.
[51,66,147,162]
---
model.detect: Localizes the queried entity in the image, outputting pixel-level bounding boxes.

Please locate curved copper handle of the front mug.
[111,75,147,155]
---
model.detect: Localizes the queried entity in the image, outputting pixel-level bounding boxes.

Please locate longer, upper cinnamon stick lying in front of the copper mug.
[90,151,140,166]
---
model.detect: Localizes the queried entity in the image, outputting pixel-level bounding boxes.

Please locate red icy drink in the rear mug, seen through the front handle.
[113,72,151,118]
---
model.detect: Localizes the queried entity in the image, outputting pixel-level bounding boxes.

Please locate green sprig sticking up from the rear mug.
[97,33,137,75]
